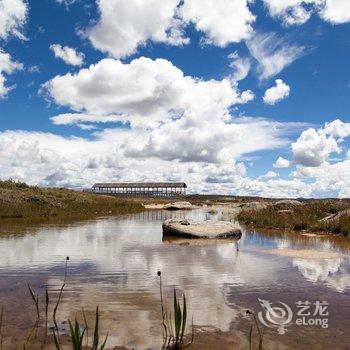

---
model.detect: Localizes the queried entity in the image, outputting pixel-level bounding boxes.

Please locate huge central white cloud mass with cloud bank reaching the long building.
[18,58,320,196]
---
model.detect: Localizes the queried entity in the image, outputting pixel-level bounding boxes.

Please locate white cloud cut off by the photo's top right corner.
[264,0,350,25]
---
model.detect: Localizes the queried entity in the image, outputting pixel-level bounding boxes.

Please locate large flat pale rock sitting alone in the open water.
[163,219,242,239]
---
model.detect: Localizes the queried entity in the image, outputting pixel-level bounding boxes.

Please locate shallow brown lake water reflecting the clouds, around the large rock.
[0,210,350,350]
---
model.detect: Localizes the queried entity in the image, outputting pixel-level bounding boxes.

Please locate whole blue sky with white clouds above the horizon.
[0,0,350,198]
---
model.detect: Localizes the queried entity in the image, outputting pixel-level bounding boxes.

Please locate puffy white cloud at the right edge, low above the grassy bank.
[266,119,350,198]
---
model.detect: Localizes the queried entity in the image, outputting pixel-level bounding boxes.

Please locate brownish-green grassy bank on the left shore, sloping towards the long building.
[0,180,144,219]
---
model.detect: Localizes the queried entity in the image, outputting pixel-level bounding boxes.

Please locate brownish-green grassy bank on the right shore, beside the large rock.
[238,200,350,236]
